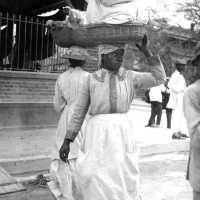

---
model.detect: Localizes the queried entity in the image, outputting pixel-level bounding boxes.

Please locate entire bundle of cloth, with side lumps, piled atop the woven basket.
[66,0,148,28]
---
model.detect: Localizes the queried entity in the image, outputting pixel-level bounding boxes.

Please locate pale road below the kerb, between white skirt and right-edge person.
[140,154,192,200]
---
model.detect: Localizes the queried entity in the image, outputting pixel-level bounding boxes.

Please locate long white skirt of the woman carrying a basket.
[75,114,140,200]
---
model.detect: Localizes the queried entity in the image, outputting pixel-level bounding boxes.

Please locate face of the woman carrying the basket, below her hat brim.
[101,48,124,71]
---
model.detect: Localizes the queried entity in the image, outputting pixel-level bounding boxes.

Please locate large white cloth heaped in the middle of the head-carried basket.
[86,0,147,24]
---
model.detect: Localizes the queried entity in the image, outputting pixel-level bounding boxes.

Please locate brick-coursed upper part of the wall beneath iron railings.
[0,72,57,103]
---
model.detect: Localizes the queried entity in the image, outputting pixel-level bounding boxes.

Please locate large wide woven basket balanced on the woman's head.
[51,21,146,47]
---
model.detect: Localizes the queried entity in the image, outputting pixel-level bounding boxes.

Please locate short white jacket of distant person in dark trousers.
[149,84,165,103]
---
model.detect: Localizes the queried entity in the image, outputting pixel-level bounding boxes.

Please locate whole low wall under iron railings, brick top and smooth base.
[0,71,58,129]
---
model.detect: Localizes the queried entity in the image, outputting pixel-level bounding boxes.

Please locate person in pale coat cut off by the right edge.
[183,49,200,200]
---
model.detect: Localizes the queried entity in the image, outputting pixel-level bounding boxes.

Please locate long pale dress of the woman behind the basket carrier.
[48,67,89,200]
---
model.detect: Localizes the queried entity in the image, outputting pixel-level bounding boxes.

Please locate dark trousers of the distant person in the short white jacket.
[148,101,162,125]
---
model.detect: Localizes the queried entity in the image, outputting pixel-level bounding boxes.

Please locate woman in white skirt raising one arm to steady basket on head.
[60,35,166,200]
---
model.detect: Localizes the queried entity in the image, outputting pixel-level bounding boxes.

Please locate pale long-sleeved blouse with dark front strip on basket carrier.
[65,56,166,141]
